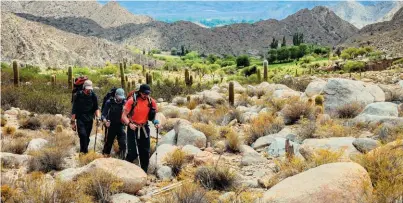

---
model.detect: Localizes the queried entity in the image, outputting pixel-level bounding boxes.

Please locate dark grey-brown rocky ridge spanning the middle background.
[0,3,358,55]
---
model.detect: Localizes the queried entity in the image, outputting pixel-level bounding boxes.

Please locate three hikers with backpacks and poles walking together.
[71,77,160,173]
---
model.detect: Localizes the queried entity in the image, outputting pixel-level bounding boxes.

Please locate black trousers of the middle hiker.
[102,123,126,159]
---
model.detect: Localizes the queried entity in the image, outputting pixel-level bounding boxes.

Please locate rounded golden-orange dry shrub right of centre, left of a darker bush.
[245,113,284,145]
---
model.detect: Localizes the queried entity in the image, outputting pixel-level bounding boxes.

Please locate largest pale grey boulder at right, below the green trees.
[323,78,385,113]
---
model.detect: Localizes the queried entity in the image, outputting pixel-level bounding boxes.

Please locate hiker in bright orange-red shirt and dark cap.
[122,84,159,173]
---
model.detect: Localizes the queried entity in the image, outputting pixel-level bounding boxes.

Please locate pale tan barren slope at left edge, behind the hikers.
[1,12,133,67]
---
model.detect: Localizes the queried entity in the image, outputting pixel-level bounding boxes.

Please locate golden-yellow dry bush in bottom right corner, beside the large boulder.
[354,140,403,202]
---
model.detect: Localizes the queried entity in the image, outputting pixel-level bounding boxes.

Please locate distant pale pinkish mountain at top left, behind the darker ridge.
[1,0,153,28]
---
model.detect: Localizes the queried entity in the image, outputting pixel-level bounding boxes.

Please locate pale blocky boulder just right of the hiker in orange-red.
[175,125,207,148]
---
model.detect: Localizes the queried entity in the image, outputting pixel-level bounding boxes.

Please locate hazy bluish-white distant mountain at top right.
[329,1,403,28]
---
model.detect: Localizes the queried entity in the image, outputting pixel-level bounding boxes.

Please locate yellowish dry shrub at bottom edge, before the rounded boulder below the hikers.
[77,170,123,203]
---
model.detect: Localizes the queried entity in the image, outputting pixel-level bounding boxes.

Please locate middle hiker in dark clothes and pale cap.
[102,88,126,159]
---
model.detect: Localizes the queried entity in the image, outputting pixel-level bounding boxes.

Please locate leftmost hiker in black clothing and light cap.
[71,80,101,154]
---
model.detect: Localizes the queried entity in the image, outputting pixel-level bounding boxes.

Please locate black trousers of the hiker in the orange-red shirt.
[126,125,150,173]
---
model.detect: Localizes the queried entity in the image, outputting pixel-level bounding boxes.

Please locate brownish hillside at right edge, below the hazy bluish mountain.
[342,8,403,56]
